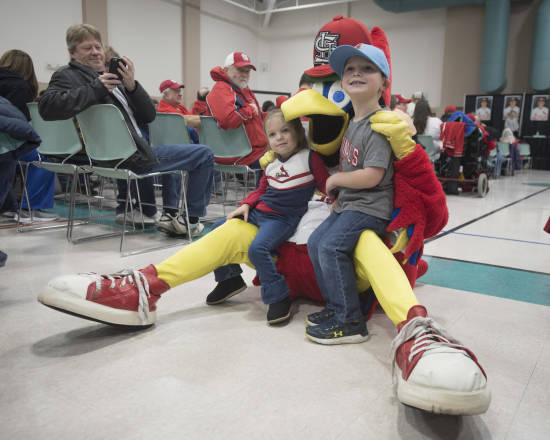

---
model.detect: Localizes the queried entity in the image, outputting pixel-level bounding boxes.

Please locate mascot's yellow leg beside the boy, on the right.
[353,231,419,326]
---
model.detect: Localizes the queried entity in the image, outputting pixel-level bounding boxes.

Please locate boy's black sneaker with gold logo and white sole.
[306,317,369,345]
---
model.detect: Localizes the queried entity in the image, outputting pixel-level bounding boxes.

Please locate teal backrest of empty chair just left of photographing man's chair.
[27,102,82,155]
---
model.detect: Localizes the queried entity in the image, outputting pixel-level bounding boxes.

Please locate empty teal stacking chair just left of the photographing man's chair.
[18,102,91,235]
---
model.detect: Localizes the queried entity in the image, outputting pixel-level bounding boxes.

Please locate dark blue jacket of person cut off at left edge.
[0,96,42,162]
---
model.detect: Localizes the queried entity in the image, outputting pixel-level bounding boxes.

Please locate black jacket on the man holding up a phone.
[38,60,157,170]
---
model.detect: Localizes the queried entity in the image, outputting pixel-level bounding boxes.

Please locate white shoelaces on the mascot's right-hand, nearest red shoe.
[391,317,469,377]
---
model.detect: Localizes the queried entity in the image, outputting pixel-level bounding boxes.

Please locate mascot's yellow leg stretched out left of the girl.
[155,219,258,287]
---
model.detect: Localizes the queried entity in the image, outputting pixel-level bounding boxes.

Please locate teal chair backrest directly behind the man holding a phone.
[76,104,137,161]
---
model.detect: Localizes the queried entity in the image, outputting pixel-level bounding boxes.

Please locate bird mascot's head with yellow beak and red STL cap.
[281,15,391,156]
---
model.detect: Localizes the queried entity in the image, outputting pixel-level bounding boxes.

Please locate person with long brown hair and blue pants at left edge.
[0,49,59,222]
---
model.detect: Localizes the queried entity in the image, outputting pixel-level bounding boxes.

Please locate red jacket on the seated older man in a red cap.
[206,67,267,165]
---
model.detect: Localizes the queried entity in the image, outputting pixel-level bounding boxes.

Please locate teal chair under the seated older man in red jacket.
[198,116,261,214]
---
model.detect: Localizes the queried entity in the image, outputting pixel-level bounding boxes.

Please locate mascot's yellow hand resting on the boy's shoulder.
[370,110,416,159]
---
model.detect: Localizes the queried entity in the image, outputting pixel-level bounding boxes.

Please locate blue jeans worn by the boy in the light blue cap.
[307,211,388,323]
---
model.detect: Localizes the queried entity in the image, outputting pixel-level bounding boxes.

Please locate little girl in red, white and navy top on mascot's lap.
[206,109,328,324]
